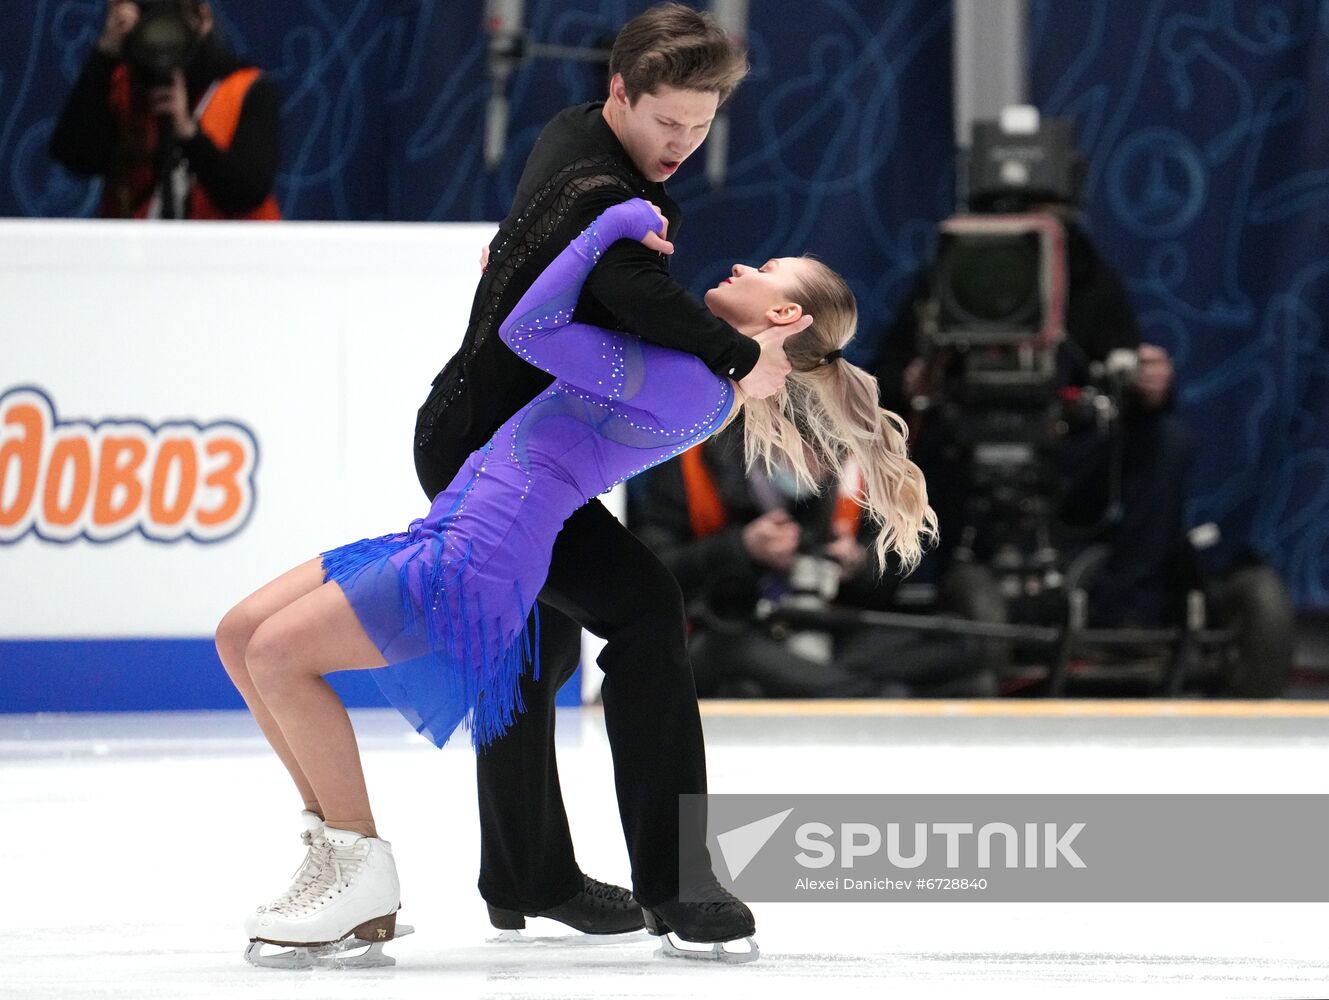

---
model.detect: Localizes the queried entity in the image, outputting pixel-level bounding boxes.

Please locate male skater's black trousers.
[416,448,710,911]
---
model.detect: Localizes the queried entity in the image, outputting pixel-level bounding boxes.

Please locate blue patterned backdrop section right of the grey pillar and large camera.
[1031,0,1329,606]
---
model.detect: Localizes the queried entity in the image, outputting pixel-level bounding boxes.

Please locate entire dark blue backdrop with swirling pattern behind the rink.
[12,0,1329,606]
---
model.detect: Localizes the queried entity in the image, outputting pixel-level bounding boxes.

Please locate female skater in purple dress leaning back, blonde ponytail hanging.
[217,199,936,964]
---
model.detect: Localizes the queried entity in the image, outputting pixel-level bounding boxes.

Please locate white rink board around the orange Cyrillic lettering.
[0,221,494,638]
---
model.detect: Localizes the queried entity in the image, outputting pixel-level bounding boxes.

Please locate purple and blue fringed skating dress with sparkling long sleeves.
[323,199,734,749]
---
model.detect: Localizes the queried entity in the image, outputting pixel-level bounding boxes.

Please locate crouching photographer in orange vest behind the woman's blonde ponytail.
[629,420,981,698]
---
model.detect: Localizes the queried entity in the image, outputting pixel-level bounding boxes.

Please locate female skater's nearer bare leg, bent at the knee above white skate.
[245,584,385,836]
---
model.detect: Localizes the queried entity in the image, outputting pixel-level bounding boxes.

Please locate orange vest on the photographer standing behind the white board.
[101,66,282,222]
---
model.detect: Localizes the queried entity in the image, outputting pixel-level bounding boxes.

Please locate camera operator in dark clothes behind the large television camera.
[876,203,1191,626]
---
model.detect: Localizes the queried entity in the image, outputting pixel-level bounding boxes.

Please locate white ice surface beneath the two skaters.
[0,709,1329,1000]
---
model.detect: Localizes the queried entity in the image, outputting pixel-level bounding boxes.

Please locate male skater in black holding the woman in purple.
[415,4,789,941]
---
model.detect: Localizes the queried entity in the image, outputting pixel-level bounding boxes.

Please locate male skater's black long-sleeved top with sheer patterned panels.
[416,102,760,486]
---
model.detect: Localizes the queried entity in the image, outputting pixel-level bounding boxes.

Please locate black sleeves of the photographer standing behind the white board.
[51,36,282,214]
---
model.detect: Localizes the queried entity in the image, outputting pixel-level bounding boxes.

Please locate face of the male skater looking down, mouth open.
[609,76,720,182]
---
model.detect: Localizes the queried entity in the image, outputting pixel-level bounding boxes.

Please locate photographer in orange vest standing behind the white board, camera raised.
[51,0,280,219]
